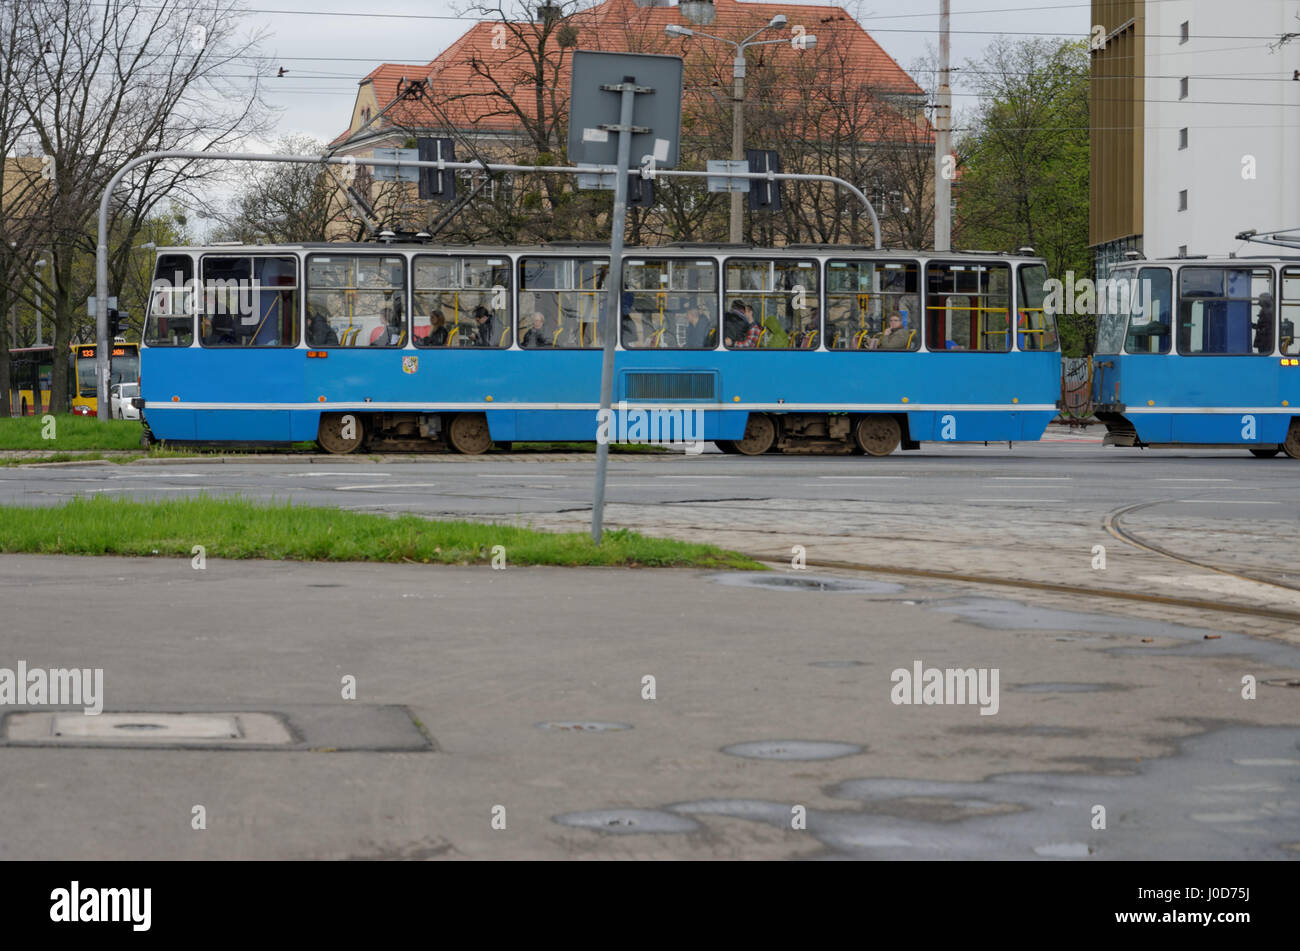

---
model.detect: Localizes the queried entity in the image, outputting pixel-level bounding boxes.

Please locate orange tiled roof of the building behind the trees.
[330,0,931,146]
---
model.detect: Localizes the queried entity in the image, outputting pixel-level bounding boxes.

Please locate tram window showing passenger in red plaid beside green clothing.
[723,259,819,349]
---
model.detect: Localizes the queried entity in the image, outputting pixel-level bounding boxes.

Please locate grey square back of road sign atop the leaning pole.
[568,49,681,169]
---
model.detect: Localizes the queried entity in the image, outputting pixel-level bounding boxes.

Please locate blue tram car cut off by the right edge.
[1092,257,1300,459]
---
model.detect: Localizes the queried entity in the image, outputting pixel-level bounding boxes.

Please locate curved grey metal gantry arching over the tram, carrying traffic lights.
[95,151,881,420]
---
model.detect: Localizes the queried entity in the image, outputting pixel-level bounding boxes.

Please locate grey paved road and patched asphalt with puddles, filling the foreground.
[0,433,1300,860]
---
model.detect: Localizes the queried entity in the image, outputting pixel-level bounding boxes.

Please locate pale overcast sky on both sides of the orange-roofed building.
[247,0,1091,140]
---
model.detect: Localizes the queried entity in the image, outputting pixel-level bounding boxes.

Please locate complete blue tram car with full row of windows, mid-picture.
[140,243,1061,455]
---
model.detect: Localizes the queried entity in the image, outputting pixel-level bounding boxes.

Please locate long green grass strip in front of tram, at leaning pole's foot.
[0,495,762,570]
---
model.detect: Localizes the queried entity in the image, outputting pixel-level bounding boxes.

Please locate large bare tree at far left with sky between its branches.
[4,0,268,411]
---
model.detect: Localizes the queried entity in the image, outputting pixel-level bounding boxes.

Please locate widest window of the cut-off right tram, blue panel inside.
[1178,268,1277,356]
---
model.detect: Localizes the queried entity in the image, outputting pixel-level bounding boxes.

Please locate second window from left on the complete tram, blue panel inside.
[199,255,298,347]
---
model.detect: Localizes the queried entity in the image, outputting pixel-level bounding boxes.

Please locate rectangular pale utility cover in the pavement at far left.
[5,712,293,746]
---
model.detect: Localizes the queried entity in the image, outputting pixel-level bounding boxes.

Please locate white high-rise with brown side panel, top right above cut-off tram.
[1089,0,1300,272]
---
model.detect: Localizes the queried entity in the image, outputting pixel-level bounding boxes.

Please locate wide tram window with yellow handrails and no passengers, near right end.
[926,262,1011,353]
